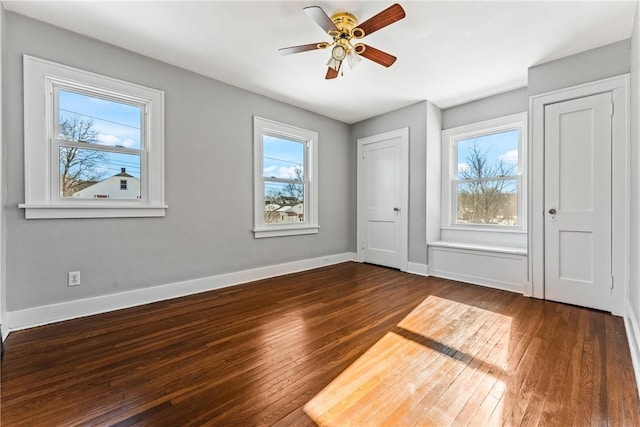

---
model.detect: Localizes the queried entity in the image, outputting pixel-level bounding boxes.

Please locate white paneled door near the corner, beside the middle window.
[358,129,408,270]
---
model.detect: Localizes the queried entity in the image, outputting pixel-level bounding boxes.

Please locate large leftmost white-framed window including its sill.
[20,55,166,218]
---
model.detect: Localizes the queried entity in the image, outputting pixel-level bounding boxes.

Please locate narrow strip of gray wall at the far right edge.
[629,4,640,344]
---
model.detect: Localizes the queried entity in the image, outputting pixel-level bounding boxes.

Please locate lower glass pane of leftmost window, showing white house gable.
[59,146,140,199]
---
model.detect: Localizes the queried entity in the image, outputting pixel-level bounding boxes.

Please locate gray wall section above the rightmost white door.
[528,39,630,96]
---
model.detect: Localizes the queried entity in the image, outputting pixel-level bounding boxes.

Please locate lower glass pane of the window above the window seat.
[457,179,518,225]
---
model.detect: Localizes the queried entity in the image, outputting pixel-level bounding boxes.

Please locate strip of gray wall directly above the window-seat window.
[442,87,529,129]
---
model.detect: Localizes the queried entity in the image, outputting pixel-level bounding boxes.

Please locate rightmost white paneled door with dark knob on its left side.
[544,93,613,311]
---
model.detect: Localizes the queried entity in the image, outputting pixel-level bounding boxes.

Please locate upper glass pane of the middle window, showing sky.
[262,135,304,181]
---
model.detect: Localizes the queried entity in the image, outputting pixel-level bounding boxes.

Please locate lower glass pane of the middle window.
[264,181,304,224]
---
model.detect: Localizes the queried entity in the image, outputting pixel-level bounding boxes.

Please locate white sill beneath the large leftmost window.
[18,204,167,219]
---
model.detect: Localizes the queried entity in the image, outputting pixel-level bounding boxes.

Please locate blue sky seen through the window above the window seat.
[458,130,518,178]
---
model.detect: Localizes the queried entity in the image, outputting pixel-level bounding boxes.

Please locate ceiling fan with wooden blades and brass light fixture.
[279,3,405,79]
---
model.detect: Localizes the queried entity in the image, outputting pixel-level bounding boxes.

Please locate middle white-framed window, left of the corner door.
[254,117,319,238]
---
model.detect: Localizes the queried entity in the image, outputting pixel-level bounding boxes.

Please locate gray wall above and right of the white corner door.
[351,101,427,264]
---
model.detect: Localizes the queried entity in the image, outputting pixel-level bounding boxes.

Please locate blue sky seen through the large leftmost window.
[58,90,142,178]
